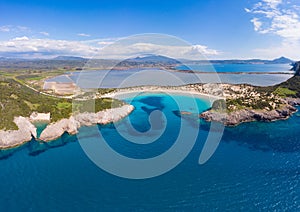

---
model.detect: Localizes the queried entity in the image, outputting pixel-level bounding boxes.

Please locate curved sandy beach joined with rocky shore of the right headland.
[101,84,300,126]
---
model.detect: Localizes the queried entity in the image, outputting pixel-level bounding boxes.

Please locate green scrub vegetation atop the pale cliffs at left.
[0,77,124,130]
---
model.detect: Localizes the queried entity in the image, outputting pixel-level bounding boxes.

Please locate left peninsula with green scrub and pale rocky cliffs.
[0,78,134,149]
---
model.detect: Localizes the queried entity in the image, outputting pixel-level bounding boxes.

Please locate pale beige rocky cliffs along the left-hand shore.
[0,105,134,149]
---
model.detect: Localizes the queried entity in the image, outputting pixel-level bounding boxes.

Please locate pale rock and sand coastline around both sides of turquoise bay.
[0,81,300,149]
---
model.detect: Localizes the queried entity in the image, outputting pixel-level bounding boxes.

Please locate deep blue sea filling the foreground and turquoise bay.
[0,94,300,211]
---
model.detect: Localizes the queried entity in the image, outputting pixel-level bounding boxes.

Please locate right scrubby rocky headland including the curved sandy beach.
[105,84,300,126]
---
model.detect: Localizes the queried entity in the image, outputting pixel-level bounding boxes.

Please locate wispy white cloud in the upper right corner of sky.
[245,0,300,60]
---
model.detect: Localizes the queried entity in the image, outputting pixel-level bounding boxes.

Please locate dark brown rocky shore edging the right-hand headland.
[199,102,300,126]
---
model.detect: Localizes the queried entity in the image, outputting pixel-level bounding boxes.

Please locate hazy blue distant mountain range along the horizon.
[0,54,294,69]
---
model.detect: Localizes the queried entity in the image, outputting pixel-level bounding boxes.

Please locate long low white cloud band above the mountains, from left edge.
[0,36,221,59]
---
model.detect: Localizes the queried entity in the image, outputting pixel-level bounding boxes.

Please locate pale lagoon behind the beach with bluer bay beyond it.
[45,64,292,88]
